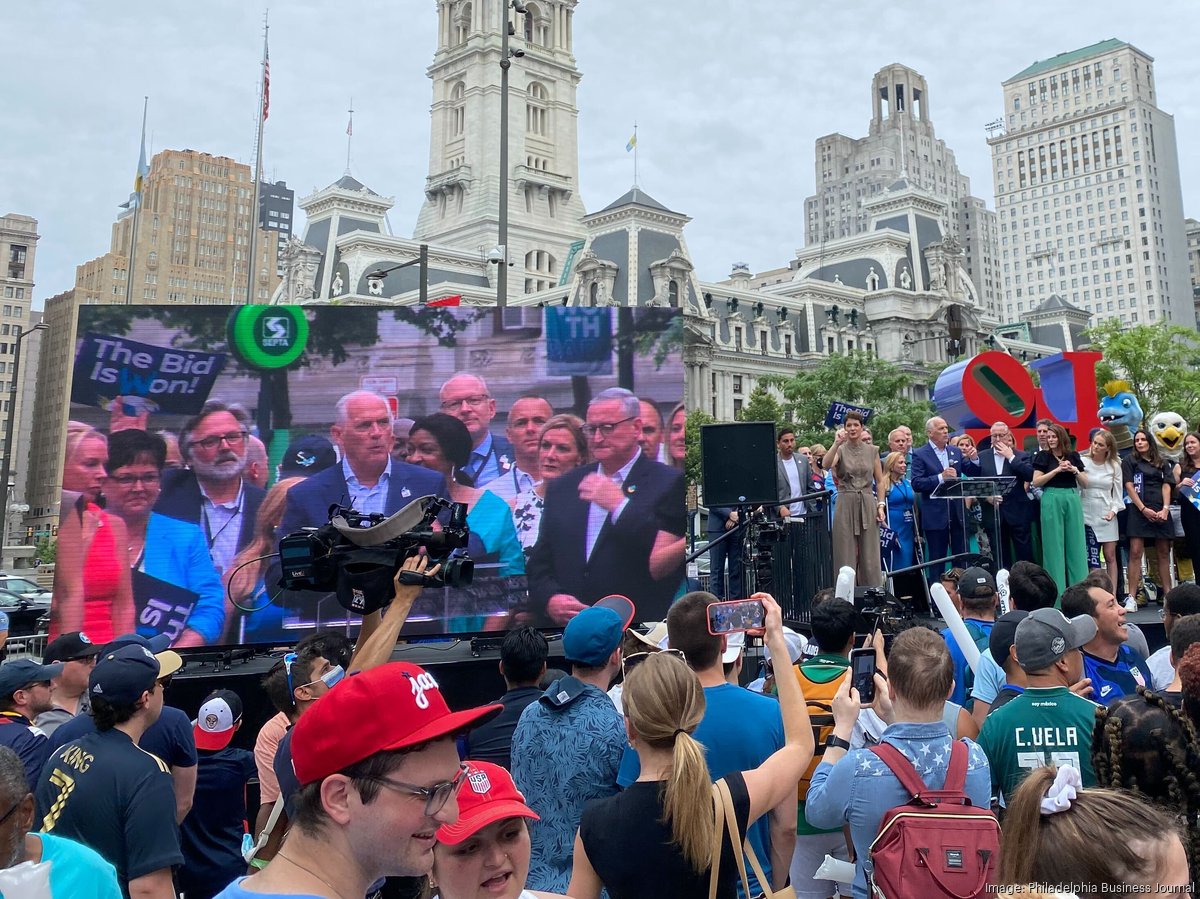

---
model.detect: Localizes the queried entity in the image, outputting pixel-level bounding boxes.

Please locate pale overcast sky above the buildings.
[0,0,1200,305]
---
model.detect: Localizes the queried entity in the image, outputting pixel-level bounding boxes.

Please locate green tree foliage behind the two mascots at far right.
[1087,319,1200,426]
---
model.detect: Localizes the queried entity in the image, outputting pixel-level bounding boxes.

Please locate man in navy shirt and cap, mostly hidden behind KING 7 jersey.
[50,634,197,821]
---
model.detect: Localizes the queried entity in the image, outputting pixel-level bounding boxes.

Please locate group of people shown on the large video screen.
[50,372,684,648]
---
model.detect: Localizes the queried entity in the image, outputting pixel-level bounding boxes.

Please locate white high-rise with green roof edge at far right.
[988,38,1195,324]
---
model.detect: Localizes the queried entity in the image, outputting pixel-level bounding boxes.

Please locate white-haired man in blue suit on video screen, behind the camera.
[278,390,446,537]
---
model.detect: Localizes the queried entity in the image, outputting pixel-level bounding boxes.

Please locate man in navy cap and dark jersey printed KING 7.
[34,643,184,899]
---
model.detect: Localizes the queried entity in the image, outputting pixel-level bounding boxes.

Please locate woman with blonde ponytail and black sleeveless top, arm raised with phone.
[566,593,812,899]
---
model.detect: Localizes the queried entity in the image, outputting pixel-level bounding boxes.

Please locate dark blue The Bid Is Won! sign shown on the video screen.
[71,331,226,415]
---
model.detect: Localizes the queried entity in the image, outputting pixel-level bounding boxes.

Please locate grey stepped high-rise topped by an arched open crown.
[804,62,1000,318]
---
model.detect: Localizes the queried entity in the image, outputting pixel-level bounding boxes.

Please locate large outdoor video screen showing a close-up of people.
[50,306,686,648]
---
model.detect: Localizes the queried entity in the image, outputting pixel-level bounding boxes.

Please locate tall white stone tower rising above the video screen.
[414,0,584,301]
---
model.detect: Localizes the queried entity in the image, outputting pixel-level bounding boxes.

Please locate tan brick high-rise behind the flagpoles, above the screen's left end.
[74,150,280,305]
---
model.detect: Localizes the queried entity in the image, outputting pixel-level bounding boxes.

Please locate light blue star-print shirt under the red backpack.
[804,721,991,899]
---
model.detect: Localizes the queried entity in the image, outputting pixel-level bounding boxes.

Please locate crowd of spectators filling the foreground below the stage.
[0,547,1200,899]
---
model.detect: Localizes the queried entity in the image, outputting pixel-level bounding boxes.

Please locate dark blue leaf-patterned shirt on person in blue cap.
[512,677,625,894]
